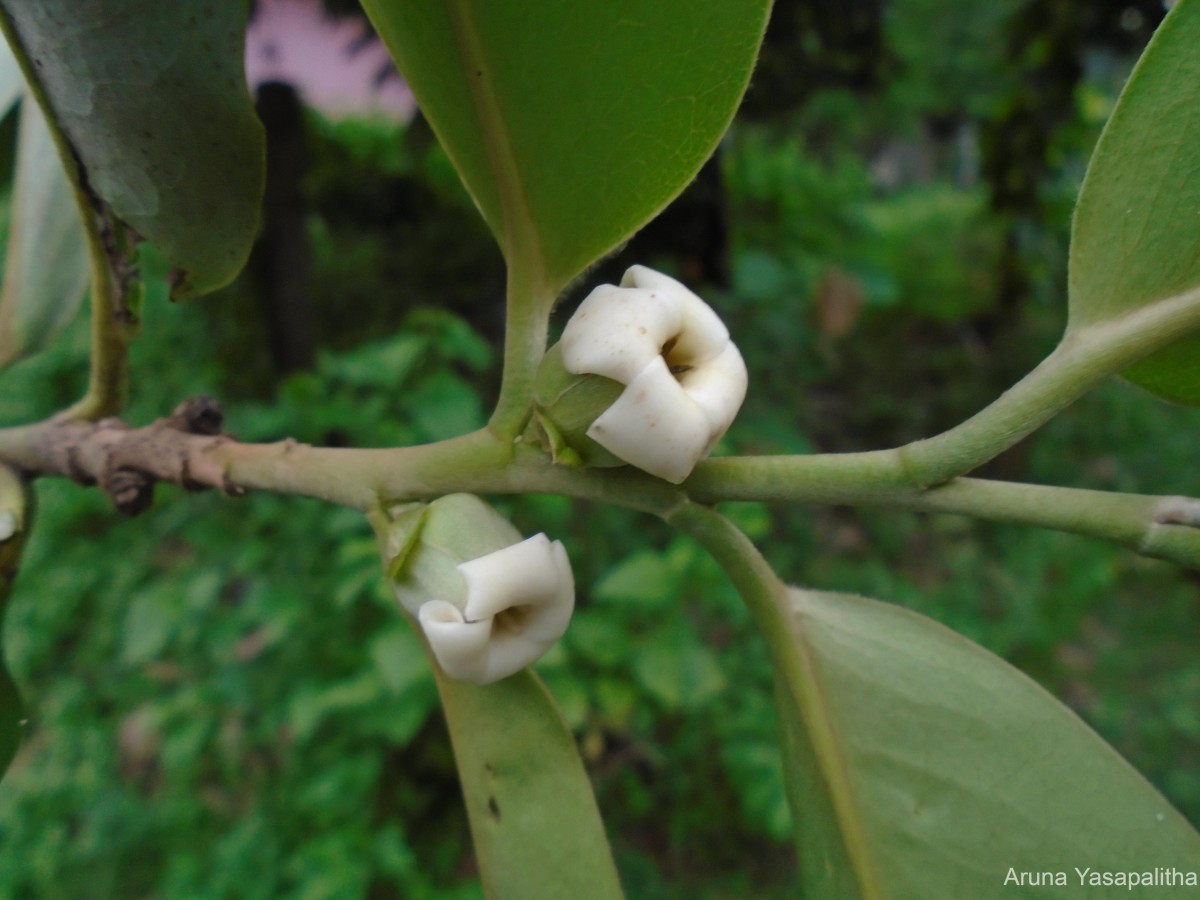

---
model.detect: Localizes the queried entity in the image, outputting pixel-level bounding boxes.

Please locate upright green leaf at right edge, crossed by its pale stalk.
[1068,0,1200,404]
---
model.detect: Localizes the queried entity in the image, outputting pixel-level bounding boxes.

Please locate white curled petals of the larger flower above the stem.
[562,265,748,484]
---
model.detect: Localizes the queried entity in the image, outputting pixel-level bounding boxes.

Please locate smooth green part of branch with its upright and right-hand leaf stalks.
[180,278,1200,542]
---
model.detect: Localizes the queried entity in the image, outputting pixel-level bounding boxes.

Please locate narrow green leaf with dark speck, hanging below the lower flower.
[437,670,622,900]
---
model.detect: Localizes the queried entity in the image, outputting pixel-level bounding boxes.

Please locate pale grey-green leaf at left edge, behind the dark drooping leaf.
[0,95,88,367]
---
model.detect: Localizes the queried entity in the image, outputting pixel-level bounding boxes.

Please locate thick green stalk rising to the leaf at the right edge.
[899,288,1200,487]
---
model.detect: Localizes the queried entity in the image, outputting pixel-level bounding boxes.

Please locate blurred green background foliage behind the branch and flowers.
[0,0,1200,900]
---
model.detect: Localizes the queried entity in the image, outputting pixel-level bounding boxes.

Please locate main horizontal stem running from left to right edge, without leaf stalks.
[9,400,1200,568]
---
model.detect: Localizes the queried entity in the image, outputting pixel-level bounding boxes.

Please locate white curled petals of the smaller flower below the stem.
[418,534,575,684]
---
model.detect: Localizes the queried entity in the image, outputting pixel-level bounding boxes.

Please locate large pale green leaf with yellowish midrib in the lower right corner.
[779,590,1200,900]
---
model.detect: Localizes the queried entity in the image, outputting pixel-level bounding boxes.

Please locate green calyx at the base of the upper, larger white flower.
[526,343,625,468]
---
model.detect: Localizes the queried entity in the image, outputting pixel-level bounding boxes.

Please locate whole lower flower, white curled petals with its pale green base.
[380,494,575,684]
